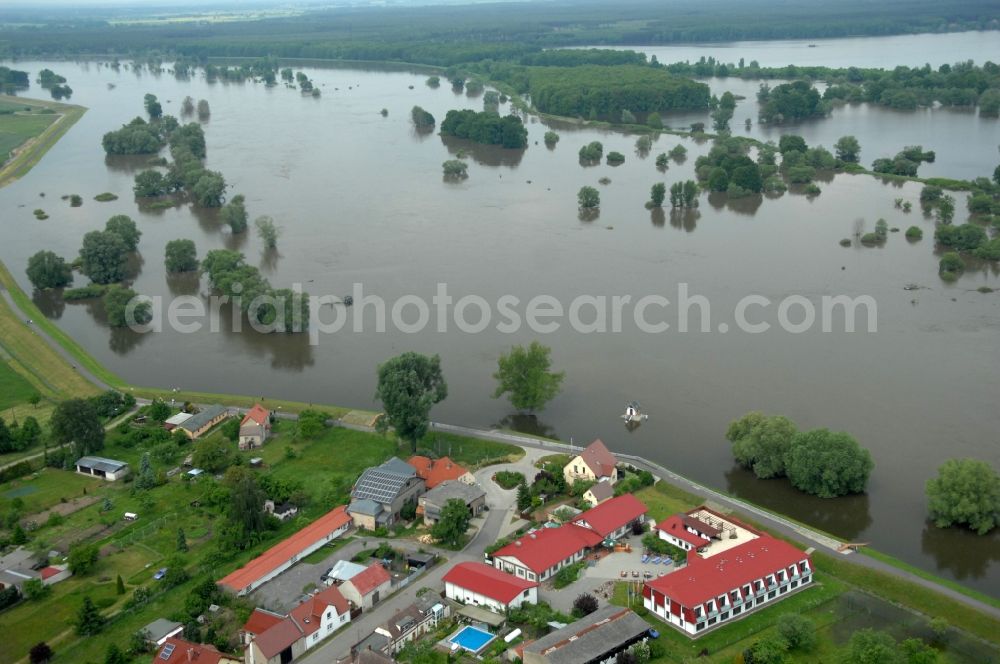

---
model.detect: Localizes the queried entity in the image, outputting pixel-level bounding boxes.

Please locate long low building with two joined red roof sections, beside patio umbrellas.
[493,494,647,581]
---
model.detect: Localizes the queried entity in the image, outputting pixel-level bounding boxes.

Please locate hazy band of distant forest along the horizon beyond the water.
[0,0,1000,66]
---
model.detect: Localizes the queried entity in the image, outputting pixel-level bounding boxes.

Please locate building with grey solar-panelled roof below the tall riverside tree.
[347,457,425,530]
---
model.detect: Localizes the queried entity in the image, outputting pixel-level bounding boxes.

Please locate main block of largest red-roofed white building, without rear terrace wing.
[642,533,812,636]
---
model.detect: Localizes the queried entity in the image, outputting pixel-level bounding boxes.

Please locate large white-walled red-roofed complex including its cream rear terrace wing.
[642,508,813,636]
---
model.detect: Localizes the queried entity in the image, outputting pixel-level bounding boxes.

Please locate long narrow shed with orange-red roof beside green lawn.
[219,505,351,595]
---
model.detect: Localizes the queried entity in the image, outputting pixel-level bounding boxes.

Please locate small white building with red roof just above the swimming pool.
[443,562,538,613]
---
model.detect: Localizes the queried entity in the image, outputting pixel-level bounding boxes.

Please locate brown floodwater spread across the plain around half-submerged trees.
[0,35,1000,594]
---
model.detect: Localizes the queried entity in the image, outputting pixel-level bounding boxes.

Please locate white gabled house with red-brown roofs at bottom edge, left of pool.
[242,587,351,664]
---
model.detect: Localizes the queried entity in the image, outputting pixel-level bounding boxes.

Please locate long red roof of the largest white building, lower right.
[646,535,808,608]
